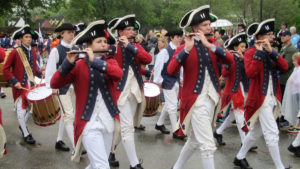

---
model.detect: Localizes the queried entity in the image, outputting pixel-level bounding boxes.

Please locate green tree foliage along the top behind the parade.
[0,0,300,33]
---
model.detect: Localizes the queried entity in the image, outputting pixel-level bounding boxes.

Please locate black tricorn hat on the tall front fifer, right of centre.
[179,5,217,28]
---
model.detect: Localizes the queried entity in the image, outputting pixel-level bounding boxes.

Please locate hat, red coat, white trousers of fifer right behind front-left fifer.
[109,14,152,169]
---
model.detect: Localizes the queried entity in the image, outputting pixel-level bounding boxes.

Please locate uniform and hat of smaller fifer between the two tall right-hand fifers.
[214,32,249,145]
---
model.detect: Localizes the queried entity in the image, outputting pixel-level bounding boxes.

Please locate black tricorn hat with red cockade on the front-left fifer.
[72,20,115,45]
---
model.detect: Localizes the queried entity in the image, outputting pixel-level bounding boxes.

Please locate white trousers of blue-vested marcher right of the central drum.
[157,82,179,132]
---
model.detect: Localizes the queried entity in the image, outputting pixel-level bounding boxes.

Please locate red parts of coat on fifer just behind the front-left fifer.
[114,43,152,97]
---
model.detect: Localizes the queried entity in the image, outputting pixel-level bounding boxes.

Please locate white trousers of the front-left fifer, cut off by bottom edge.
[82,121,113,169]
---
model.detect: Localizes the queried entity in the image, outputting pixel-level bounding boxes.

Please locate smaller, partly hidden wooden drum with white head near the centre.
[144,81,160,117]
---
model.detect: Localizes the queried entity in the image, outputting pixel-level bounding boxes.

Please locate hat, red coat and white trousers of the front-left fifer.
[51,20,123,169]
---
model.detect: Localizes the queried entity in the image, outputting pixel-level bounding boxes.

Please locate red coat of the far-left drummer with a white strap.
[3,48,39,101]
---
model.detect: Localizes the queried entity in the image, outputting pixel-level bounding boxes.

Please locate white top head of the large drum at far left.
[27,86,52,101]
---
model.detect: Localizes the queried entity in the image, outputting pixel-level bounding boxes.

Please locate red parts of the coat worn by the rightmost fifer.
[243,47,288,131]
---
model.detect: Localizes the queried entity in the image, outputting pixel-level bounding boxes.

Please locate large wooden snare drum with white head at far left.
[26,84,60,126]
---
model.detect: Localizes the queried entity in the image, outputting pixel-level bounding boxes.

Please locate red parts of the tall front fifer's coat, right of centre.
[168,41,233,133]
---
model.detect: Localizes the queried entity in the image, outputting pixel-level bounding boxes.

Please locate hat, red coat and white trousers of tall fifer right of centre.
[168,5,232,169]
